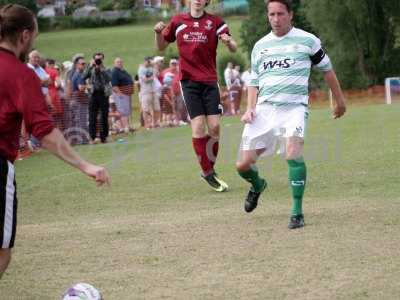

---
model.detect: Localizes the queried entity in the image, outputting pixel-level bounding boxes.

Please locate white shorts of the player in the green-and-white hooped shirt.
[240,103,308,155]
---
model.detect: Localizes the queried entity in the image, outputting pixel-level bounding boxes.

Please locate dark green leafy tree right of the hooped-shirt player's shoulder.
[304,0,400,87]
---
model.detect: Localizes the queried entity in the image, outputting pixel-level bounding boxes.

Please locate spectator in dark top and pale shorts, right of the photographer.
[111,57,134,132]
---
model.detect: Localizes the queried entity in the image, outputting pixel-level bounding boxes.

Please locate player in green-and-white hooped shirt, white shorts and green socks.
[236,0,346,229]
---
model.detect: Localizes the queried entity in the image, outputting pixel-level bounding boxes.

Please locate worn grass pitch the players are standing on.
[0,105,400,300]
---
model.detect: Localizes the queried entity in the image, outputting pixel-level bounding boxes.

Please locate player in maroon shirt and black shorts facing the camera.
[154,0,237,192]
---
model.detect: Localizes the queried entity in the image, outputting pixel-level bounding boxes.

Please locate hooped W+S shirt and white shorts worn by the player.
[242,27,332,154]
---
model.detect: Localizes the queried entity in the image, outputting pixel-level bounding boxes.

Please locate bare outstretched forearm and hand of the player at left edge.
[41,128,110,185]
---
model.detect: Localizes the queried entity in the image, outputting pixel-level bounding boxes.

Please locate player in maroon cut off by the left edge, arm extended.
[0,4,110,278]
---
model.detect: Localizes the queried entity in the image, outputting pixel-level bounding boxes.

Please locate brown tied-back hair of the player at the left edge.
[0,4,36,44]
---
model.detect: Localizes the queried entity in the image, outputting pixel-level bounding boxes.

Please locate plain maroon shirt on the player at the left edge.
[0,48,54,162]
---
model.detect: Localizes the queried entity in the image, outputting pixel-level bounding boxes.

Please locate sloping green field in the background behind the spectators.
[35,17,247,74]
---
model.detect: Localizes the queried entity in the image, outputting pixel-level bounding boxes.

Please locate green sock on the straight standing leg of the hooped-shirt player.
[287,158,307,216]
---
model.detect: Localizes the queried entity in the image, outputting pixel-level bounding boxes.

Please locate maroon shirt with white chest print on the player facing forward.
[162,12,229,82]
